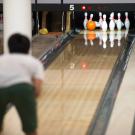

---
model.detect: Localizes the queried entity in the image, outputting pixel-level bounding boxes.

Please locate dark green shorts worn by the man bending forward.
[0,83,37,133]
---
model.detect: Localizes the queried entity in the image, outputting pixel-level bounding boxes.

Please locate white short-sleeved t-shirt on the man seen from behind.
[0,54,43,87]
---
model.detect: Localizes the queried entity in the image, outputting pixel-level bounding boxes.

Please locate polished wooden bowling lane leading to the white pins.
[38,31,126,135]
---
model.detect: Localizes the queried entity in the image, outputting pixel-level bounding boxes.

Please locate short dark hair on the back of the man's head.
[8,33,30,54]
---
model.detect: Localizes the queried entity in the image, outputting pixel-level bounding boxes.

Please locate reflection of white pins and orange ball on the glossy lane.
[83,30,128,49]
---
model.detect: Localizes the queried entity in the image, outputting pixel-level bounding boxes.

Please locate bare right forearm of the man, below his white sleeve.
[33,79,43,97]
